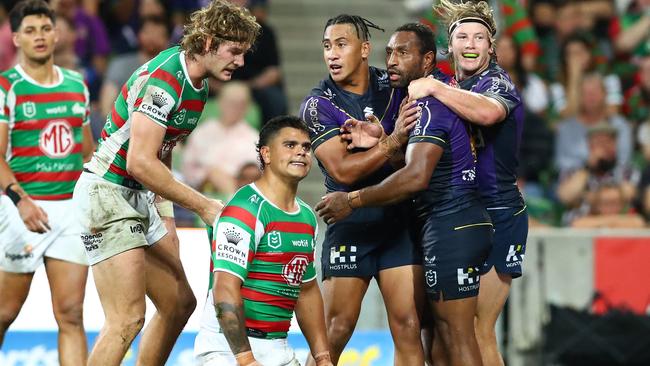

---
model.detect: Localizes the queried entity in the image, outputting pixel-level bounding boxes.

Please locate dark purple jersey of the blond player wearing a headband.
[460,63,524,207]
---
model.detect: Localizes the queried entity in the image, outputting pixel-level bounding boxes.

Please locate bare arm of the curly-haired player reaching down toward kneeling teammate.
[126,112,222,224]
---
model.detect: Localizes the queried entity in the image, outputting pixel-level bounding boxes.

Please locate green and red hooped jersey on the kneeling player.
[212,183,318,339]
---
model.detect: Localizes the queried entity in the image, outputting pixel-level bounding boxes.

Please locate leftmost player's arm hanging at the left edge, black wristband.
[0,101,50,233]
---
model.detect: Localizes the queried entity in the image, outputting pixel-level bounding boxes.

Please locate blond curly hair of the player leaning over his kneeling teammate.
[181,0,260,55]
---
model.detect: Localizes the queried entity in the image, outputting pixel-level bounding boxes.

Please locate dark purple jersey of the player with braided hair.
[299,67,401,192]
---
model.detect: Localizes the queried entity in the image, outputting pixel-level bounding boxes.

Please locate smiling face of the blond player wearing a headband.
[449,23,492,80]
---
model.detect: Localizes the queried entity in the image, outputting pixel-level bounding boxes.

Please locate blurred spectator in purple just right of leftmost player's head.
[51,0,111,101]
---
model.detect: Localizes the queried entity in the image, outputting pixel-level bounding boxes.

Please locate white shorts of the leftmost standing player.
[0,195,88,273]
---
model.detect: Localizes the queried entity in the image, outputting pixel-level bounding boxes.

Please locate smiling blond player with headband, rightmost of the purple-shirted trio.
[409,0,528,365]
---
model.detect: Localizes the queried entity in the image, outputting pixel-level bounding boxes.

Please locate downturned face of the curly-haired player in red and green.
[204,41,250,81]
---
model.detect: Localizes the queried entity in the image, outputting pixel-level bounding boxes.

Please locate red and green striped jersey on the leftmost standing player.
[0,65,90,200]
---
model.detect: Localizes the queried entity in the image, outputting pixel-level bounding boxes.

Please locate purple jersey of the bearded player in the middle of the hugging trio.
[409,97,480,216]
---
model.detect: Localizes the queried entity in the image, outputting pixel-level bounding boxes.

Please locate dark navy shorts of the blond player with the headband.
[481,206,528,278]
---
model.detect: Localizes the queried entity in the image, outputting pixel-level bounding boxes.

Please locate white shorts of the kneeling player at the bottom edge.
[194,291,300,366]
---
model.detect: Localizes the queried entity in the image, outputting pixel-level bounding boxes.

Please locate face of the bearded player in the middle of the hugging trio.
[386,32,426,88]
